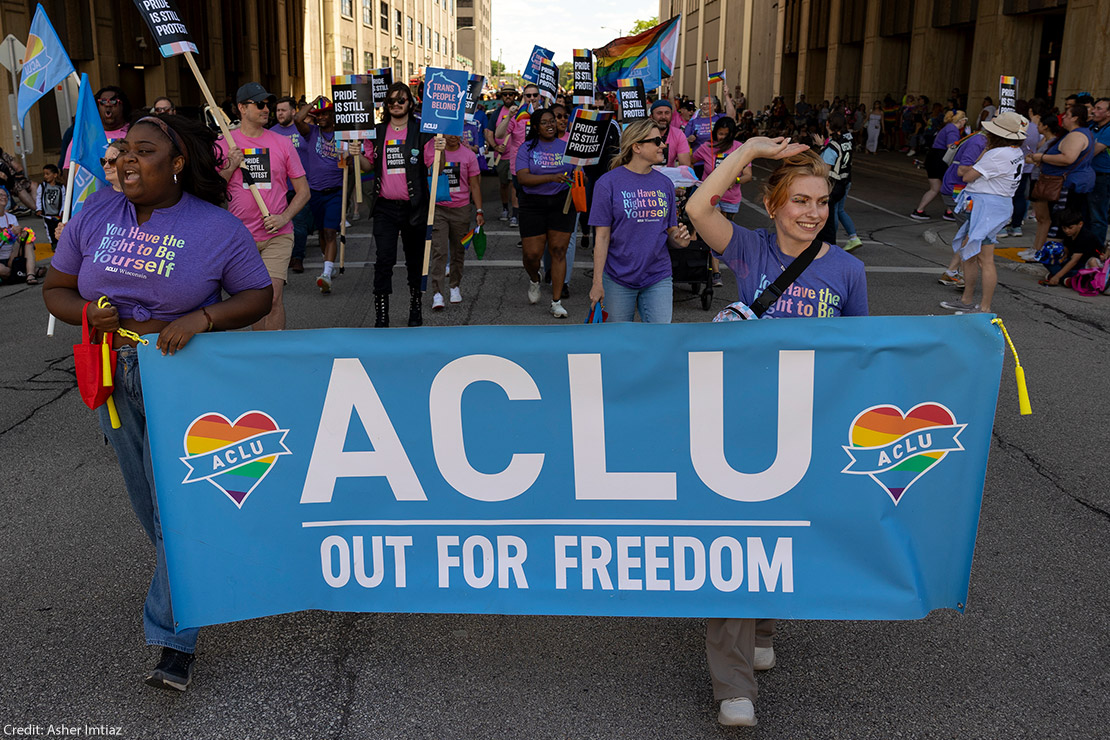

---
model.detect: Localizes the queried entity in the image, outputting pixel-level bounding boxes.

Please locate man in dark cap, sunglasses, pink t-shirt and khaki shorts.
[218,82,309,331]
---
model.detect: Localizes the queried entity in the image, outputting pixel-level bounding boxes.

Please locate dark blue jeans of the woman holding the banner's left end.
[98,347,200,652]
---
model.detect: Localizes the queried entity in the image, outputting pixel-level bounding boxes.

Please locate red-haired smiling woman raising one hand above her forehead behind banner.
[686,136,867,726]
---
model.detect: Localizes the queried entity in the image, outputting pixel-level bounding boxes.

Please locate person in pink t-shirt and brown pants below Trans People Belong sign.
[424,134,485,311]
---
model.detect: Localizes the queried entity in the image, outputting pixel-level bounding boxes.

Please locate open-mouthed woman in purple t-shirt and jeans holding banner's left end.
[43,115,273,691]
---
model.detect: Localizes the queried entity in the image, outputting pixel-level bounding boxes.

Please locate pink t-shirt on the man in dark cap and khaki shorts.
[216,129,304,242]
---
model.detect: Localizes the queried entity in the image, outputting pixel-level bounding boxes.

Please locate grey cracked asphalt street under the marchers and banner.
[0,148,1110,739]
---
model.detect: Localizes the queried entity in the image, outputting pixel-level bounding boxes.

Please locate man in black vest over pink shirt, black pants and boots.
[364,82,431,328]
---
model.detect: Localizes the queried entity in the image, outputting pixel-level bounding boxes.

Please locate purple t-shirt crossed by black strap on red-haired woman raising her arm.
[720,224,867,318]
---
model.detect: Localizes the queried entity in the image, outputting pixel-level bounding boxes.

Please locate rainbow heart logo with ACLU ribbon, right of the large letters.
[841,402,967,506]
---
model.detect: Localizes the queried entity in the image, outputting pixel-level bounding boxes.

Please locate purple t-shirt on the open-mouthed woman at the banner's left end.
[51,191,271,322]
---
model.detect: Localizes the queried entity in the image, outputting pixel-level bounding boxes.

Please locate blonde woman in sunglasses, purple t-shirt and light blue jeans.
[589,119,690,324]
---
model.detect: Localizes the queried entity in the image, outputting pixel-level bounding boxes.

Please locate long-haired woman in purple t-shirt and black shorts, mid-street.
[516,108,578,318]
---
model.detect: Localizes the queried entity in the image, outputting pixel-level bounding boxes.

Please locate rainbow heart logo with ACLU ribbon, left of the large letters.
[181,410,292,508]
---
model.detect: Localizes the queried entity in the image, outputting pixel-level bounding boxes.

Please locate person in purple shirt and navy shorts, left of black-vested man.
[293,95,344,295]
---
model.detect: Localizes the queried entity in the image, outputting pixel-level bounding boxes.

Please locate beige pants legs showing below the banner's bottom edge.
[705,617,775,702]
